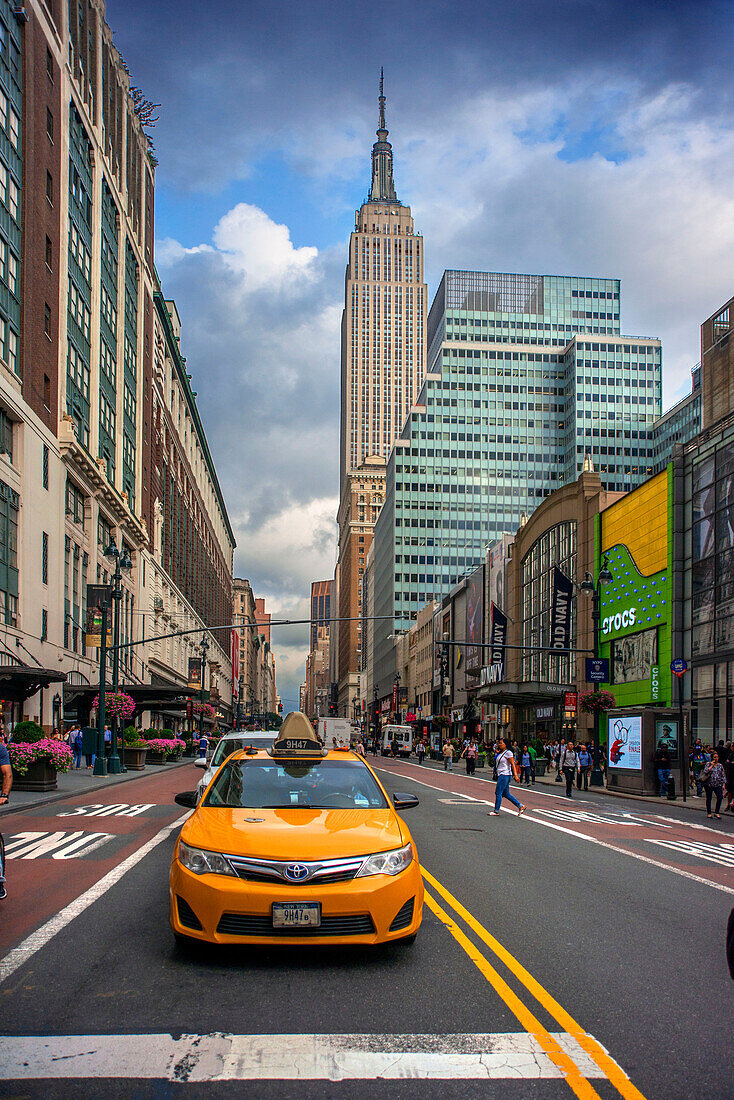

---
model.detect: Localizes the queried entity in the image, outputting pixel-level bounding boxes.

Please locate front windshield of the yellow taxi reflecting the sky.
[204,760,387,810]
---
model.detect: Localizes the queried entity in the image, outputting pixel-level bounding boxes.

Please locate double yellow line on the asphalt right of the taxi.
[421,867,645,1100]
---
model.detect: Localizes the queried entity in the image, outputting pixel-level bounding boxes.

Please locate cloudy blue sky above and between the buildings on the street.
[107,0,734,711]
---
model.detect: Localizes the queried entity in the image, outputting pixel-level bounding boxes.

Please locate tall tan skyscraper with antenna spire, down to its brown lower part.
[332,76,428,714]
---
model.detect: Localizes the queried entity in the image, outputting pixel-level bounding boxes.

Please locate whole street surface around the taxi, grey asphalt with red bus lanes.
[0,761,734,1100]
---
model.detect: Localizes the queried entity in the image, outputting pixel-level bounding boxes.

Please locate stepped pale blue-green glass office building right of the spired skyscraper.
[374,271,661,660]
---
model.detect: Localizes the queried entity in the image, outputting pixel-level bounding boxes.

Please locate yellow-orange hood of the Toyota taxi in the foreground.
[180,806,409,860]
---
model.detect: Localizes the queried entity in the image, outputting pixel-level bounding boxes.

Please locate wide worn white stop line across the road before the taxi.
[0,1032,605,1085]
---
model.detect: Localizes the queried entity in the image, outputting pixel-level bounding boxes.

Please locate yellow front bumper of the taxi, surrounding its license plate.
[169,858,424,944]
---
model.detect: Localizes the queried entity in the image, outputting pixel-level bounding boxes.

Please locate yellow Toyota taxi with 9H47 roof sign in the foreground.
[169,712,424,944]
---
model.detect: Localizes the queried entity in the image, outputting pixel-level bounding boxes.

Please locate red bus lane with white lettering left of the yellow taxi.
[0,766,198,955]
